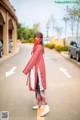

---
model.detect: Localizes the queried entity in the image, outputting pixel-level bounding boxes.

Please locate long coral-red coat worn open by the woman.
[23,44,46,91]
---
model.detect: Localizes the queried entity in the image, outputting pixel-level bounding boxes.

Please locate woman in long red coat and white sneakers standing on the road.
[23,32,50,116]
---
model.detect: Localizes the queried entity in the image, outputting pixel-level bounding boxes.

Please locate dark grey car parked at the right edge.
[69,40,80,61]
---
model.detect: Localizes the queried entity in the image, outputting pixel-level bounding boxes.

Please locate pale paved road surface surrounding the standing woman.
[0,44,80,120]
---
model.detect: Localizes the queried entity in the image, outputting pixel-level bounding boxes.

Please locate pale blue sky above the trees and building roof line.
[9,0,74,36]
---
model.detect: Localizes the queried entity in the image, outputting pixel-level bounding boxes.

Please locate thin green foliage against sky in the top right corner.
[64,4,80,38]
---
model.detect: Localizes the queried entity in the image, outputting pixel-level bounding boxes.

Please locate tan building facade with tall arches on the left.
[0,0,18,55]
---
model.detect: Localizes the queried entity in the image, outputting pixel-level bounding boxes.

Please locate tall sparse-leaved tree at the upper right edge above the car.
[67,4,80,38]
